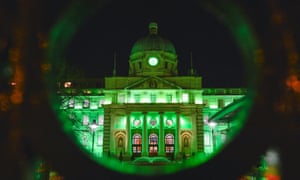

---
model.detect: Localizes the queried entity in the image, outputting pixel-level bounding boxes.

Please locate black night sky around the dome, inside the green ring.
[66,0,244,87]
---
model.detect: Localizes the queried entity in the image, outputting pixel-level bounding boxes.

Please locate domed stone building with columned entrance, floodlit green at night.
[58,22,246,160]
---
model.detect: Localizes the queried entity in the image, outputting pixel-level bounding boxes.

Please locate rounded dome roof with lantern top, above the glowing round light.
[131,22,176,54]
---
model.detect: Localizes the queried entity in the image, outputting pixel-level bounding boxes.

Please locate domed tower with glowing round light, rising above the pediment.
[129,22,178,76]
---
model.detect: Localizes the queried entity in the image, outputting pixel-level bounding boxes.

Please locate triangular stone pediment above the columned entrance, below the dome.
[125,76,182,89]
